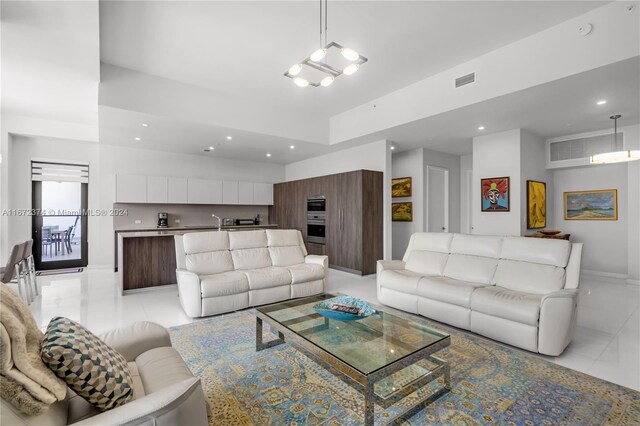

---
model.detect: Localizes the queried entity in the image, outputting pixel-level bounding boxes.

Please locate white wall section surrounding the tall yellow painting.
[512,130,554,235]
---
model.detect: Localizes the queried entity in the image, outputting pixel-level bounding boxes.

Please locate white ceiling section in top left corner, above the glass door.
[0,0,100,124]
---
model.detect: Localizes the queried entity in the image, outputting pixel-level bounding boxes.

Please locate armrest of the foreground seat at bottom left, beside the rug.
[73,377,207,426]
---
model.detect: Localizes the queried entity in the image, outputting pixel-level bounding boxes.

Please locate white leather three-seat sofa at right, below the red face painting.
[377,233,582,356]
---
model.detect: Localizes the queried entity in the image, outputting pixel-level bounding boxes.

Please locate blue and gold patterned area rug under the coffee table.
[170,310,640,426]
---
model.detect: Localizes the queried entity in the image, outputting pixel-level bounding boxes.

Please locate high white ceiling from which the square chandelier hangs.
[100,1,606,118]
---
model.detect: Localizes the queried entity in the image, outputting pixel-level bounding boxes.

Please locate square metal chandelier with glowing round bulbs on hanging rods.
[284,0,368,87]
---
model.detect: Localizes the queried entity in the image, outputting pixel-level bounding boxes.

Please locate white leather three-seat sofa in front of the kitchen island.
[175,229,328,317]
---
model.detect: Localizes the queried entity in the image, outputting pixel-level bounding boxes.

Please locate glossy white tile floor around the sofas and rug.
[25,269,640,390]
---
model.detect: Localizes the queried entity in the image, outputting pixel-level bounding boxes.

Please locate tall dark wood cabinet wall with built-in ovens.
[269,170,383,275]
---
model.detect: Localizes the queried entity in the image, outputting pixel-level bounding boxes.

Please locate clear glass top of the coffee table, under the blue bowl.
[257,294,449,375]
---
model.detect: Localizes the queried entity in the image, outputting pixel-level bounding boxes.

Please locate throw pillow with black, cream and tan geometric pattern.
[40,317,133,410]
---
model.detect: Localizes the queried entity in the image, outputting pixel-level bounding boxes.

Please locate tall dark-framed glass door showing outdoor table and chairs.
[31,163,89,270]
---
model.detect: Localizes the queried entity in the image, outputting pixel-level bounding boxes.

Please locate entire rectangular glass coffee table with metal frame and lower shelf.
[256,294,451,425]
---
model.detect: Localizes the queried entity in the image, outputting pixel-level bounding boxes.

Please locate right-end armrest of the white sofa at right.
[538,289,578,356]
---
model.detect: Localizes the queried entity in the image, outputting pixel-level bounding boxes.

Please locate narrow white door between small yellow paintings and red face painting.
[425,166,449,232]
